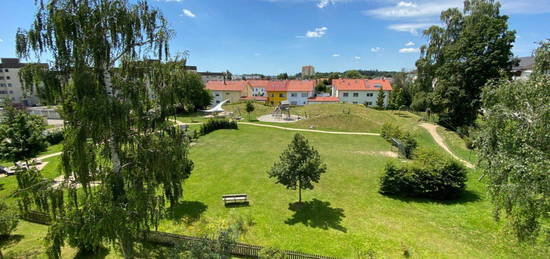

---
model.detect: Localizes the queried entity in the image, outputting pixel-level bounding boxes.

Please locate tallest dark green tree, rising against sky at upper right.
[413,0,515,126]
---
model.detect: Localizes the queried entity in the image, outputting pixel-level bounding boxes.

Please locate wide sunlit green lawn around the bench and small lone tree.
[160,125,547,258]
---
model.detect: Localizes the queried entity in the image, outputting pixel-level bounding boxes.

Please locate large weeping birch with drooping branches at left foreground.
[16,0,193,258]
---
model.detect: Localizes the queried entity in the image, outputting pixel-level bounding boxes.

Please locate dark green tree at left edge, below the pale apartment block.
[0,101,48,167]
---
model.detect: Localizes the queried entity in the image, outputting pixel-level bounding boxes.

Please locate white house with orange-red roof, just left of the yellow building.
[206,80,248,105]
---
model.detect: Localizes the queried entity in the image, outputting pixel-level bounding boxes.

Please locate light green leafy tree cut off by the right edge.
[476,41,550,242]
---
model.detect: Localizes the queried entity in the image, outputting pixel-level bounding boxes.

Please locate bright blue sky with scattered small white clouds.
[0,0,550,75]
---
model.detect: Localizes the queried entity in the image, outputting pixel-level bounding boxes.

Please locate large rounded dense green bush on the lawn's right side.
[380,149,466,200]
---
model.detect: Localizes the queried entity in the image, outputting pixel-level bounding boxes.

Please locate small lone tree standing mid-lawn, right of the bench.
[268,133,327,203]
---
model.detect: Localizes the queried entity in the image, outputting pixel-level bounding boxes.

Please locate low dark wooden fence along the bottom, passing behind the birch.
[21,211,338,259]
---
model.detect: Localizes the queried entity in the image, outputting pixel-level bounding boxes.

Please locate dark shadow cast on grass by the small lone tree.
[285,199,347,233]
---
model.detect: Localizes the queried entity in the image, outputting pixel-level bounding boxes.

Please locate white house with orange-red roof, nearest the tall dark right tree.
[332,79,392,106]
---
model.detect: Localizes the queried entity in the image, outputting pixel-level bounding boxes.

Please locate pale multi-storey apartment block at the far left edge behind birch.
[0,58,43,106]
